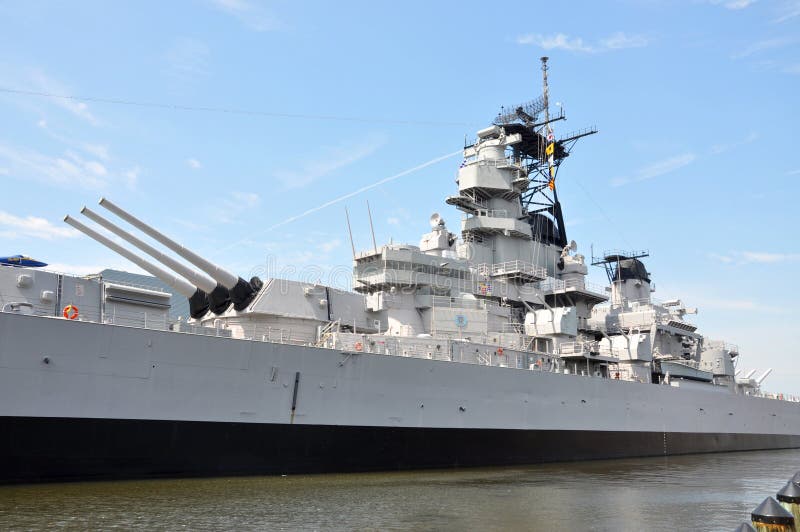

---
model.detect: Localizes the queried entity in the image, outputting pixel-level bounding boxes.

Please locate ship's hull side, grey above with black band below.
[0,313,800,482]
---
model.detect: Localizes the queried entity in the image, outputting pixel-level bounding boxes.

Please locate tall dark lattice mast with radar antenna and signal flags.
[494,57,597,247]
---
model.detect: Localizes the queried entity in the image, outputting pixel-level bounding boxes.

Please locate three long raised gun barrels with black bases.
[64,198,262,319]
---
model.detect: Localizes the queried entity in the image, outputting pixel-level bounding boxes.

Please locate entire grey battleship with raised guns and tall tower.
[0,58,800,483]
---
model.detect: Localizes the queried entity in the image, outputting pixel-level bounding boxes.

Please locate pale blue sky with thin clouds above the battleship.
[0,0,800,394]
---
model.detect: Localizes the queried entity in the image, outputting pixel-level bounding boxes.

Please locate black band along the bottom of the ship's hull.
[0,417,800,483]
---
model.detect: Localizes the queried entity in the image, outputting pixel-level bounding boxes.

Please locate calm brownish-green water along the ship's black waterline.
[0,450,800,532]
